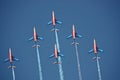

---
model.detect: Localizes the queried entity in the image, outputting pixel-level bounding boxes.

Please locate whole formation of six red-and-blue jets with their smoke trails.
[4,11,103,80]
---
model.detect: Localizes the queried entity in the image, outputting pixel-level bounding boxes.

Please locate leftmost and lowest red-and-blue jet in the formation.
[4,48,19,68]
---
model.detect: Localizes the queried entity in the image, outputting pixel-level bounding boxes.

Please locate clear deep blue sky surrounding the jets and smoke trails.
[0,0,120,80]
